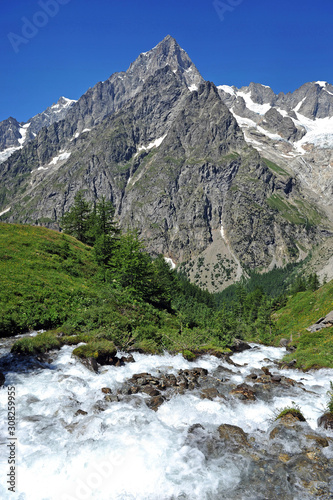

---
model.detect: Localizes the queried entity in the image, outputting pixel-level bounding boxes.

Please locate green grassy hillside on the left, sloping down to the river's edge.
[0,224,231,354]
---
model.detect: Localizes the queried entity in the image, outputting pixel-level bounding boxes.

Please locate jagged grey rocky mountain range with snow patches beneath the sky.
[0,36,333,291]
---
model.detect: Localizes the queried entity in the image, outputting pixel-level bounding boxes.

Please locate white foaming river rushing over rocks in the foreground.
[0,334,333,500]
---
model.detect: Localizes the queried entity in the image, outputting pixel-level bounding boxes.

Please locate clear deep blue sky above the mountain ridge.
[0,0,333,121]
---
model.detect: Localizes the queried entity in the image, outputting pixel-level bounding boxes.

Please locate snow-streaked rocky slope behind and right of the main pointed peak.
[218,81,333,207]
